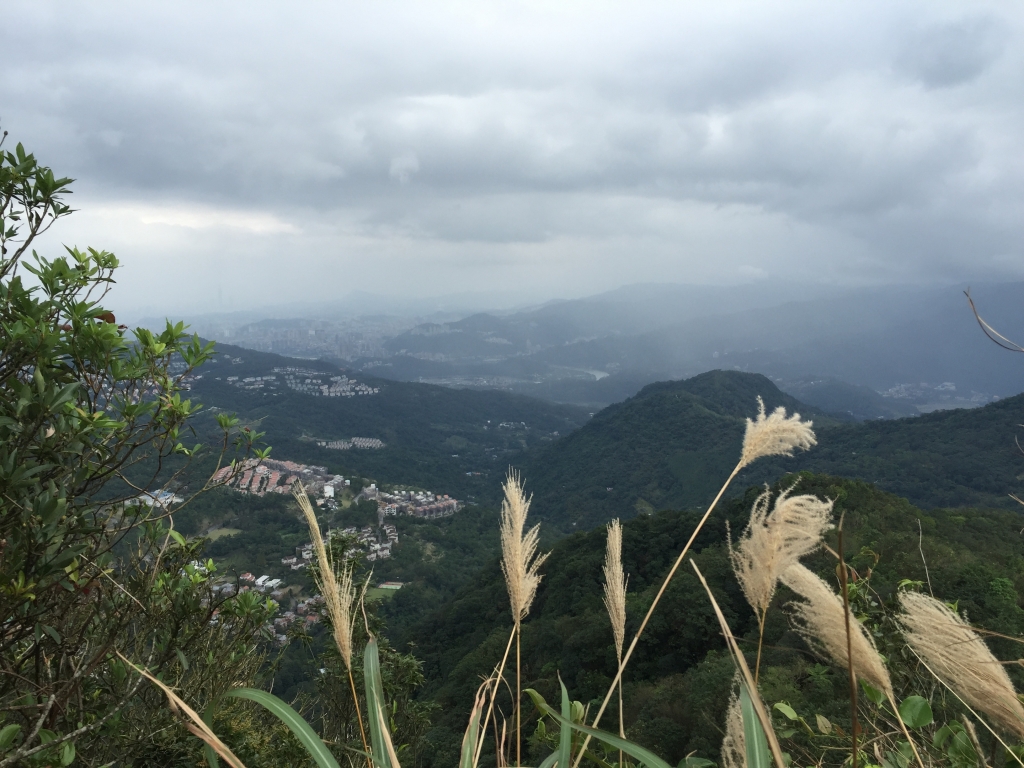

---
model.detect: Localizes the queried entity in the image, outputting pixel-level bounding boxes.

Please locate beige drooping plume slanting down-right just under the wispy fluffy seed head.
[780,563,893,697]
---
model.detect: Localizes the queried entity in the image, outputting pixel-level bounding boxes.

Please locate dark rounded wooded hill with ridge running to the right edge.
[521,371,1024,530]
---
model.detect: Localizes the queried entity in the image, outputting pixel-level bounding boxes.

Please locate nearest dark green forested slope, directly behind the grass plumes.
[388,474,1024,766]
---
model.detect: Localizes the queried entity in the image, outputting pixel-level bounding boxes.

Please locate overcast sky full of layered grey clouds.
[0,0,1024,312]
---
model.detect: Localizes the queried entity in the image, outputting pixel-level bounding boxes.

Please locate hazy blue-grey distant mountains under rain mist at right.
[356,284,1024,419]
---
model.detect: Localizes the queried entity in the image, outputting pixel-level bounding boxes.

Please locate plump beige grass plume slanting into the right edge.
[899,592,1024,737]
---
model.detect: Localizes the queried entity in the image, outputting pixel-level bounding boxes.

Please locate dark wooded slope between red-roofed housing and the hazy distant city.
[191,344,588,496]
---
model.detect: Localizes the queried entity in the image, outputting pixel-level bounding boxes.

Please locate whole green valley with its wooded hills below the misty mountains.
[159,345,1024,766]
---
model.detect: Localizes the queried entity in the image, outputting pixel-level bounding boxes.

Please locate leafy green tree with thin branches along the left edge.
[0,132,267,766]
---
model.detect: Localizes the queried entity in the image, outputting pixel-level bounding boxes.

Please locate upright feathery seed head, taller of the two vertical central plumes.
[501,471,550,627]
